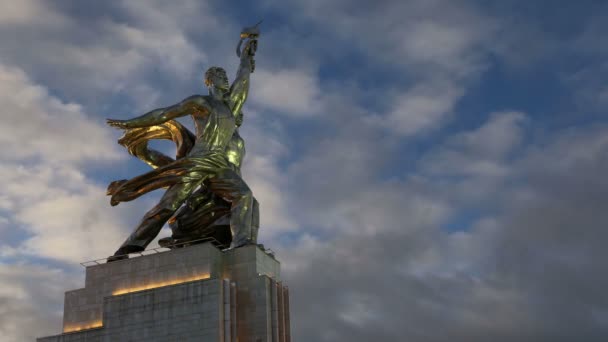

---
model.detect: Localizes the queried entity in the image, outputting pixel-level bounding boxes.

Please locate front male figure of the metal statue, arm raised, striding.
[107,27,259,261]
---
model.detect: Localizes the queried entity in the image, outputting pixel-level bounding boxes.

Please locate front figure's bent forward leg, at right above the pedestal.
[209,170,253,248]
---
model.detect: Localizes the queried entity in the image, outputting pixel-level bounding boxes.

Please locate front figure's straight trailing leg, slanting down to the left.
[114,182,199,256]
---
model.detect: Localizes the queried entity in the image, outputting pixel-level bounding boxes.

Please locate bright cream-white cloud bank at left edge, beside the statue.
[0,65,131,263]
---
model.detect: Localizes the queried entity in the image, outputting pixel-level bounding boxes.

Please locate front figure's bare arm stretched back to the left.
[106,95,209,128]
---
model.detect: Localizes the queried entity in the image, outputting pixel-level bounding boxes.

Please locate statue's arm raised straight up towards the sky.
[230,22,261,115]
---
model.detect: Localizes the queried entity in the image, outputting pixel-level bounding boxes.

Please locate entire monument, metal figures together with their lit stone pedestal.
[37,25,291,342]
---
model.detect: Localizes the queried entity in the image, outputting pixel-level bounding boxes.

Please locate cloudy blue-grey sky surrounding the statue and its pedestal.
[0,0,608,342]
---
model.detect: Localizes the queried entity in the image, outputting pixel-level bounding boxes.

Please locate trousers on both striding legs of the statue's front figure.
[116,169,254,255]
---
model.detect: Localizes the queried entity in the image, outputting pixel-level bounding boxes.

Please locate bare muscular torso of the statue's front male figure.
[189,97,236,156]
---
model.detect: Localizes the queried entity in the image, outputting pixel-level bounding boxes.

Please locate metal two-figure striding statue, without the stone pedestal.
[107,23,259,262]
